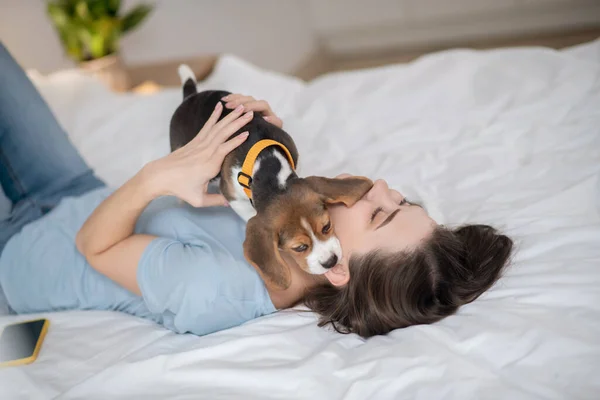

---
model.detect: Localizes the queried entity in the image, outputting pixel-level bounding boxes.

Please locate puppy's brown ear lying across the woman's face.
[305,176,373,207]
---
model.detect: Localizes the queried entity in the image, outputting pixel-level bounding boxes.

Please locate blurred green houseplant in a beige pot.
[47,0,152,90]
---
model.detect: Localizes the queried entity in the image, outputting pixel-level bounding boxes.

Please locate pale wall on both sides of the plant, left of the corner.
[0,0,315,73]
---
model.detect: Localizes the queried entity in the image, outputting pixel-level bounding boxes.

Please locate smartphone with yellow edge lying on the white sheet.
[0,318,50,367]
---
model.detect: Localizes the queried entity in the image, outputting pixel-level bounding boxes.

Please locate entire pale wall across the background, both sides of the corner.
[0,0,600,73]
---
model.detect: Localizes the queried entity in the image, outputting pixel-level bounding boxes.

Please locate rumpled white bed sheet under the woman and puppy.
[0,41,600,399]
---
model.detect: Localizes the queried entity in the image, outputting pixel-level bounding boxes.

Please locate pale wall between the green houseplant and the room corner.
[118,0,316,72]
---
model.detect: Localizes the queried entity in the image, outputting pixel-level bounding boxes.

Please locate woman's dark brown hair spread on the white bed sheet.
[304,225,513,337]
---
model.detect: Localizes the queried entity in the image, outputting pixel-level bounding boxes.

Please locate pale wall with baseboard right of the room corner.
[307,0,600,55]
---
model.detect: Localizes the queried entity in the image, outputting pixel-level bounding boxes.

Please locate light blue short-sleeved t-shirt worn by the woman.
[0,188,275,335]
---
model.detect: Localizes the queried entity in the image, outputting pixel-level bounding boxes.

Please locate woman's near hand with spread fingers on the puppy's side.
[143,102,253,207]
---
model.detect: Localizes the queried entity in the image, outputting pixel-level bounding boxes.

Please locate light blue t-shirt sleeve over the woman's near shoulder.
[138,234,275,335]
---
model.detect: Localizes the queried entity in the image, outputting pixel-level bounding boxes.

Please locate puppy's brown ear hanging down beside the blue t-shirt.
[244,215,292,290]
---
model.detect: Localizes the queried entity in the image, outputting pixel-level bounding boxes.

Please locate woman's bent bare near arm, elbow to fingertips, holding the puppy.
[75,103,252,295]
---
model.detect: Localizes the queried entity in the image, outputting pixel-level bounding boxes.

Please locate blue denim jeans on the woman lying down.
[0,42,104,253]
